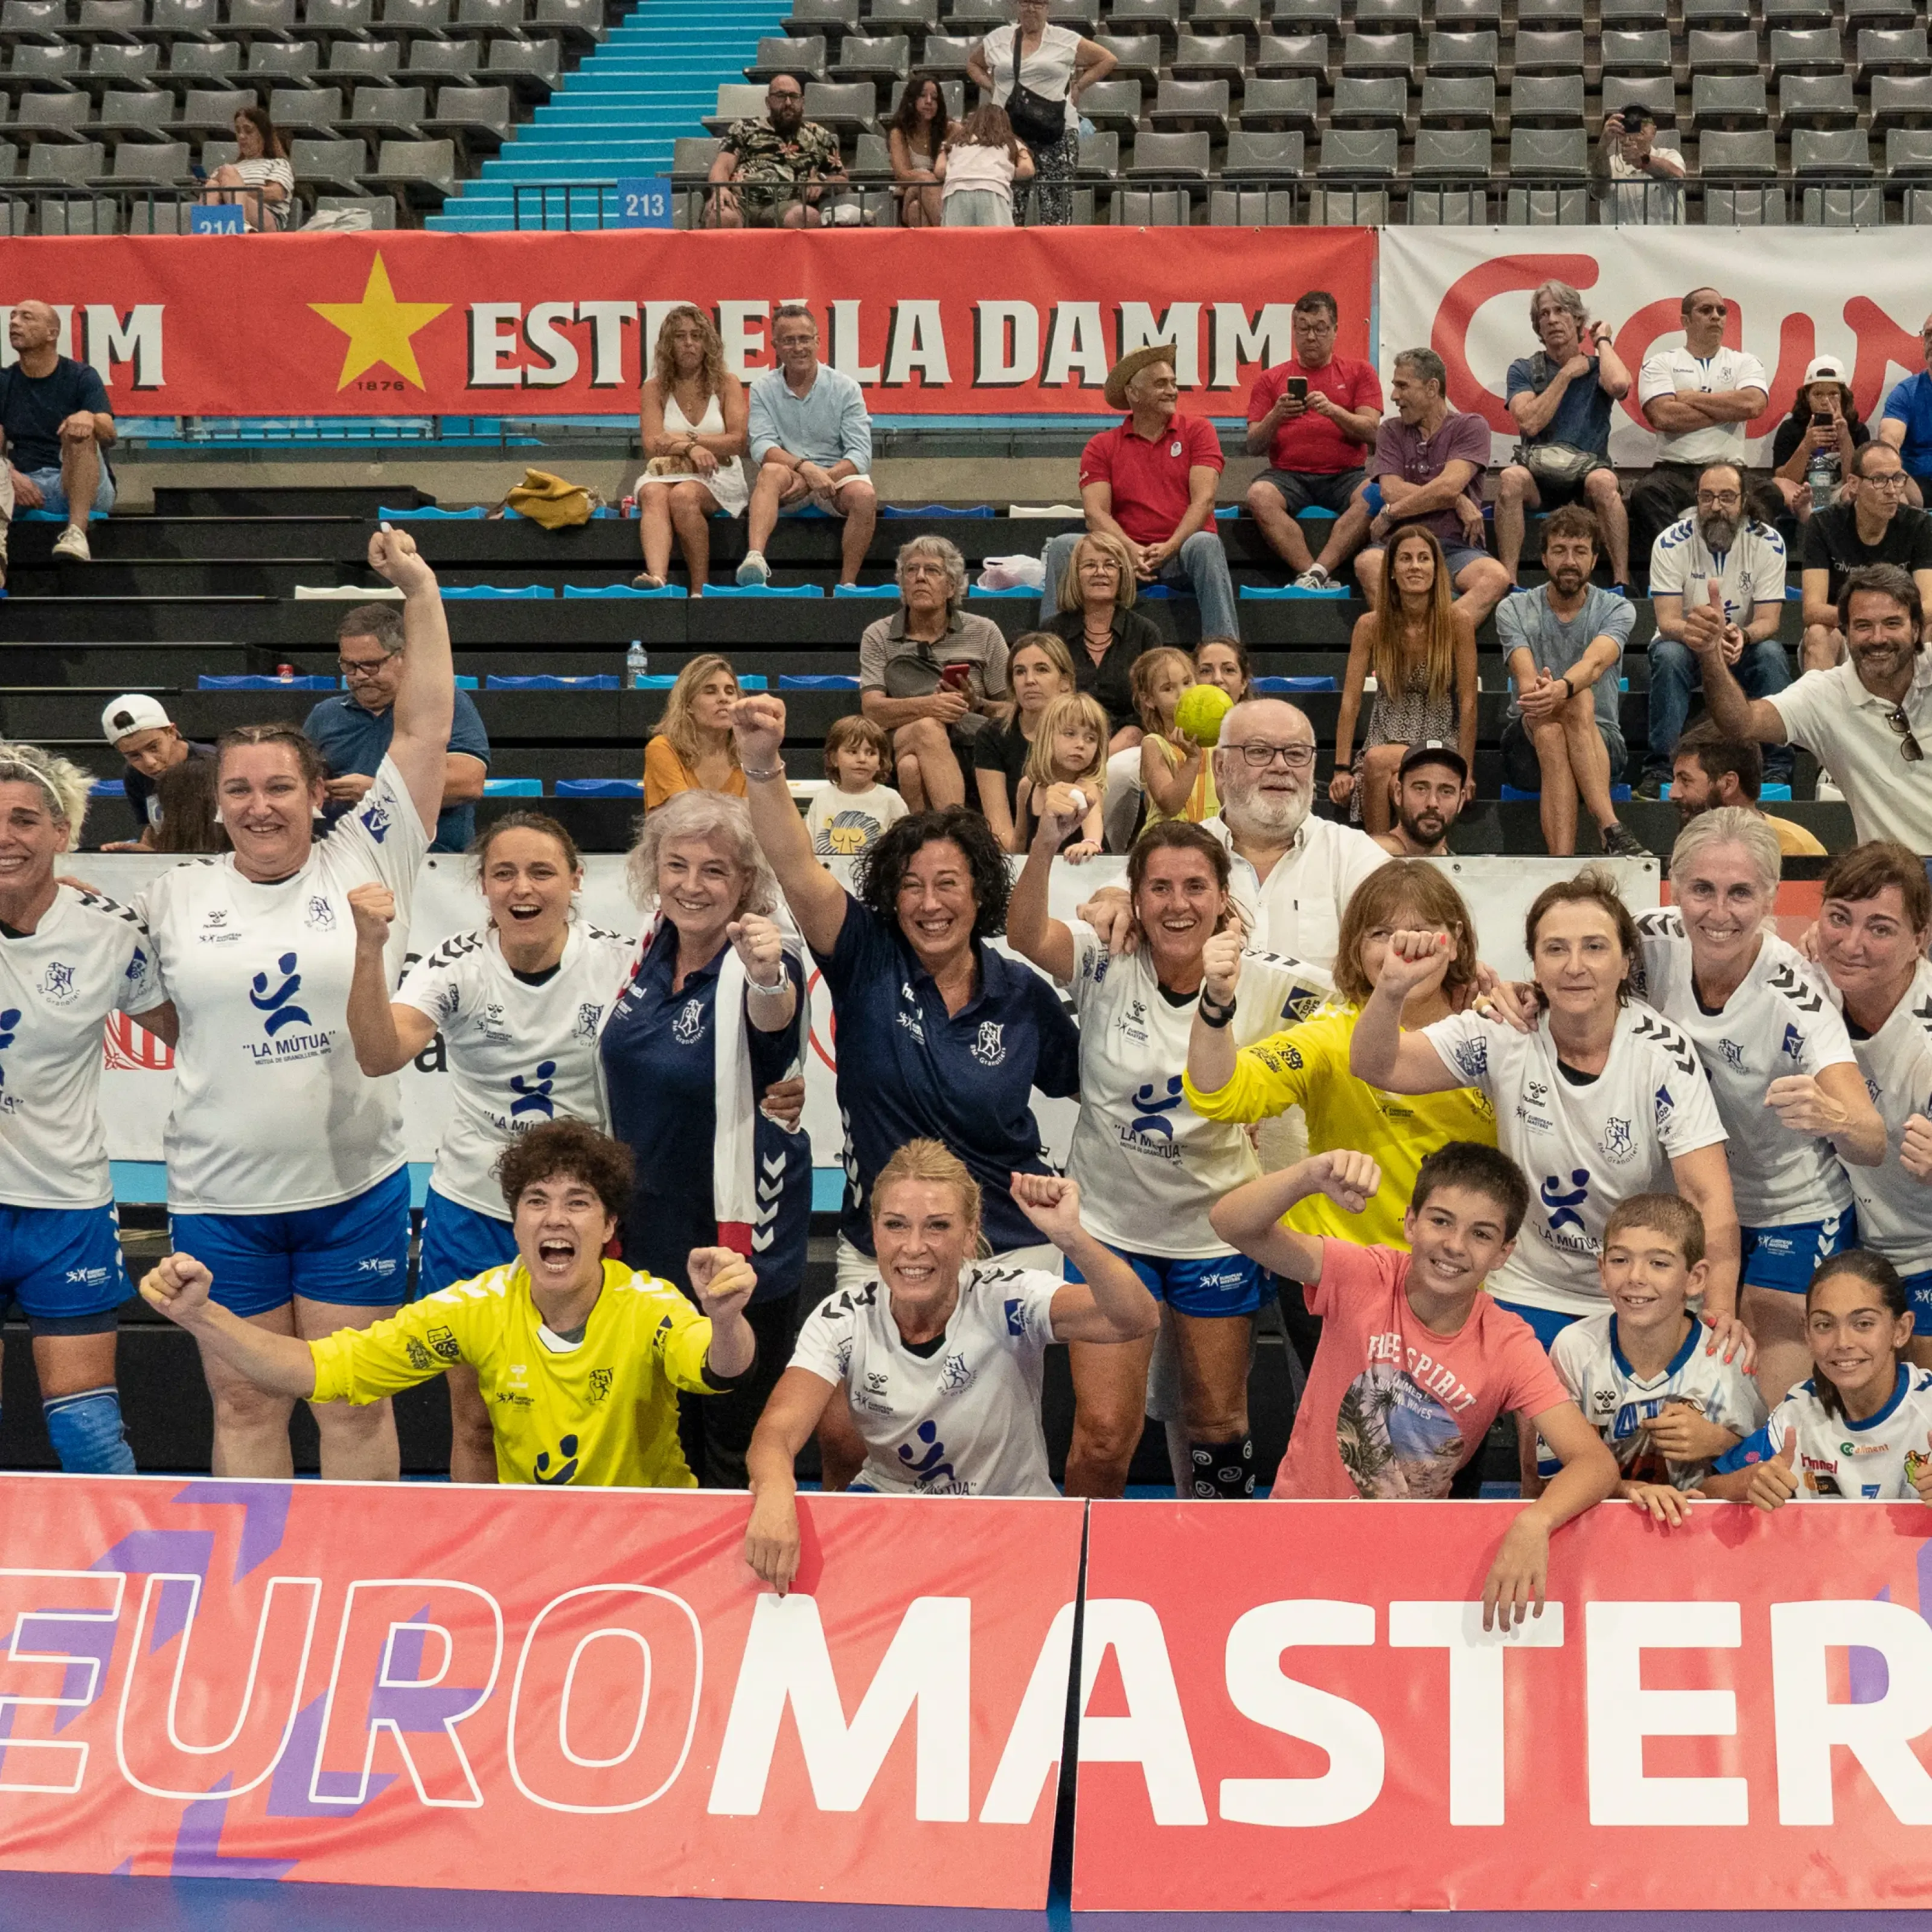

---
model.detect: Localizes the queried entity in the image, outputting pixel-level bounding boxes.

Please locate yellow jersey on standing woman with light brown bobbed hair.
[1186,1006,1495,1248]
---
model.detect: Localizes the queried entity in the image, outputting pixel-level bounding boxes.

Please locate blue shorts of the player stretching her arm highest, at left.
[168,1167,409,1316]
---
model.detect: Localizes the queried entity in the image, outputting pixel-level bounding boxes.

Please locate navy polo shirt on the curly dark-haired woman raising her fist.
[819,898,1080,1254]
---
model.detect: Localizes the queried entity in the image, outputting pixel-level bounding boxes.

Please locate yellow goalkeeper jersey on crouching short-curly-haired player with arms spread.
[309,1262,732,1489]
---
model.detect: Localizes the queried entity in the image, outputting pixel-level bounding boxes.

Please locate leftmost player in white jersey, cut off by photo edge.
[0,744,164,1476]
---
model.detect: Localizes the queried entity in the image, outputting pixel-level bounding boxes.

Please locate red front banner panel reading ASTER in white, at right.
[1074,1503,1932,1911]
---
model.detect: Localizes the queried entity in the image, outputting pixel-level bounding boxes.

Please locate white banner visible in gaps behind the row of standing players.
[91,852,1658,1167]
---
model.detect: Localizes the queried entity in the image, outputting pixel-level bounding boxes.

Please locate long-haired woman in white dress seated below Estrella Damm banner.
[632,303,752,597]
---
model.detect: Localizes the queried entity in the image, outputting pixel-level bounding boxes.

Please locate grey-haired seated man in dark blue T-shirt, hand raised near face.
[1495,282,1631,589]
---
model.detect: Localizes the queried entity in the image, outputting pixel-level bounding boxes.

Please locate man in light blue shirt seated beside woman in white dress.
[738,301,879,583]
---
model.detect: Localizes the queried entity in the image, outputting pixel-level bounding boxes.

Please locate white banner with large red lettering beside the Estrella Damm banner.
[1380,228,1932,465]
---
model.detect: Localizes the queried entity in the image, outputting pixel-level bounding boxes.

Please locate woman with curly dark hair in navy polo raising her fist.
[732,697,1080,1288]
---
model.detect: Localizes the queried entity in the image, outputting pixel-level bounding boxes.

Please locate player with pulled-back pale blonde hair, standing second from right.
[1636,805,1886,1403]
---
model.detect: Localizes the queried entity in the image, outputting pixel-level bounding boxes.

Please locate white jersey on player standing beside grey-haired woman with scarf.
[396,920,638,1221]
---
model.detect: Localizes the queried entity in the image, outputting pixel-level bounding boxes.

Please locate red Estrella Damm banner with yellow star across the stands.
[0,228,1375,415]
